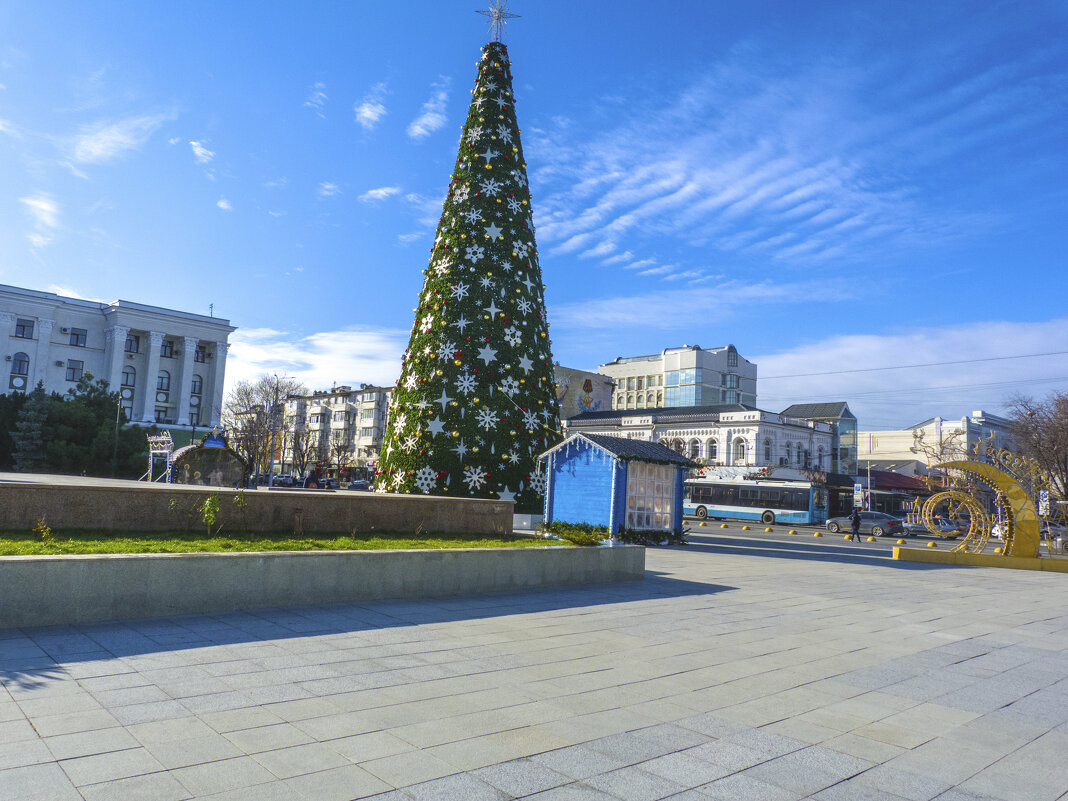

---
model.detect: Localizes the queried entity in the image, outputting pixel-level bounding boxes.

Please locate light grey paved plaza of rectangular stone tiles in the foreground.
[0,529,1068,801]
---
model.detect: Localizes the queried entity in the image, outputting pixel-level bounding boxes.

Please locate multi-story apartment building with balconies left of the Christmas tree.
[282,383,393,469]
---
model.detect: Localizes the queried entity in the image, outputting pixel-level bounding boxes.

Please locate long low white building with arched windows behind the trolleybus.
[564,404,835,472]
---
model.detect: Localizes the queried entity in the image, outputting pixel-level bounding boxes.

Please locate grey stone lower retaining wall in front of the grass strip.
[0,542,645,628]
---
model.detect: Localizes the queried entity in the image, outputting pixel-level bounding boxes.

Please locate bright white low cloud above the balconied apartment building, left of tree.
[226,327,403,389]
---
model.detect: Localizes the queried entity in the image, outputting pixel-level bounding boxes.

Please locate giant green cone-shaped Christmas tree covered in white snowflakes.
[375,32,560,513]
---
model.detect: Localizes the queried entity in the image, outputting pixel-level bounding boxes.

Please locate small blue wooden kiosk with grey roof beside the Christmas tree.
[538,434,696,536]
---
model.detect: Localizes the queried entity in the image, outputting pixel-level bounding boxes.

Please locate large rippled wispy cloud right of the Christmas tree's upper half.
[525,43,1066,277]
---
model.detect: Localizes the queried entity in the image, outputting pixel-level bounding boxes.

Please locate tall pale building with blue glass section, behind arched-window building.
[597,345,756,409]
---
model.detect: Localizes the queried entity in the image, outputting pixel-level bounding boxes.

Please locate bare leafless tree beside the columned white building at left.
[222,375,308,472]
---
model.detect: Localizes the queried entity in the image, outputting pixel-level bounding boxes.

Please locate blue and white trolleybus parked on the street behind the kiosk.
[682,468,827,525]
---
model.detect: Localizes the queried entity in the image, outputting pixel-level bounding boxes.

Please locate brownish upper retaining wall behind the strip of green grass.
[0,482,513,535]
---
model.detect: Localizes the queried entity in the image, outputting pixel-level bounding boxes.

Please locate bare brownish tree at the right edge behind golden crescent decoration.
[1008,392,1068,511]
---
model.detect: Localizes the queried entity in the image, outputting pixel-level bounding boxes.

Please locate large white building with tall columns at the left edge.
[0,284,236,427]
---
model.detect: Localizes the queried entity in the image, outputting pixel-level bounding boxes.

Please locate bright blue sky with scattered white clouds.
[0,0,1068,428]
